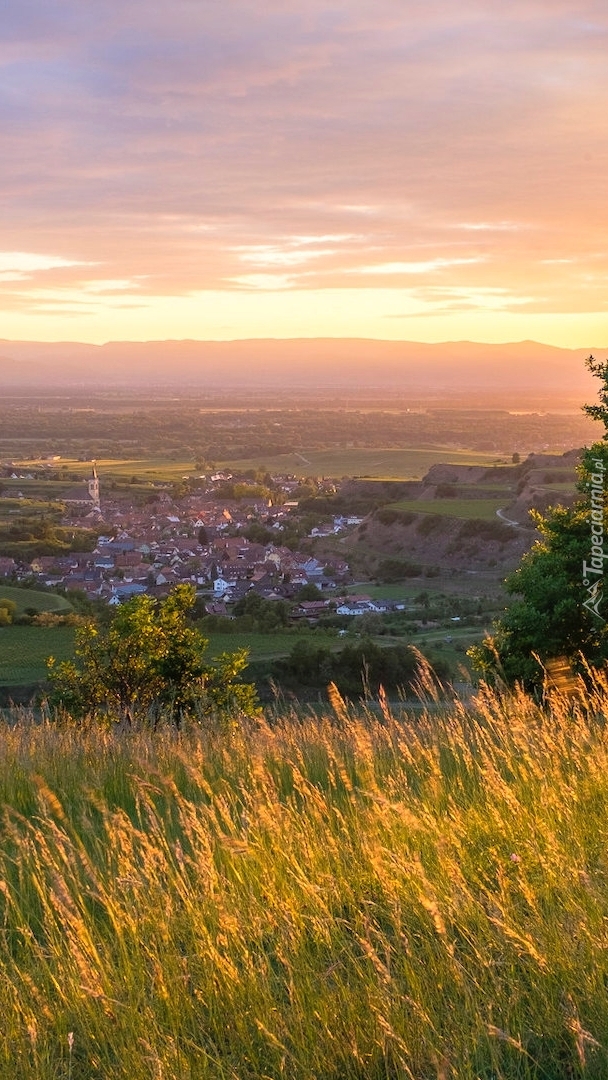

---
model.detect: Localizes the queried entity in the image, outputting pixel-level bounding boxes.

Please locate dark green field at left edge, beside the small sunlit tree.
[0,626,75,686]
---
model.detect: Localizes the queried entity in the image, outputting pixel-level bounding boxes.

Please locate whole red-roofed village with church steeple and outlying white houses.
[0,463,414,622]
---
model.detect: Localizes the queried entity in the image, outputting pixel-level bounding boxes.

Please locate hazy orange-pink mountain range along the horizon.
[0,338,608,407]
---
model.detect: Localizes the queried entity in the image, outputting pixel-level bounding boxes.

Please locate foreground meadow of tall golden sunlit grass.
[0,688,608,1080]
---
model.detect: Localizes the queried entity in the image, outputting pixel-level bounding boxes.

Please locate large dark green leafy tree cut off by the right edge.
[470,356,608,687]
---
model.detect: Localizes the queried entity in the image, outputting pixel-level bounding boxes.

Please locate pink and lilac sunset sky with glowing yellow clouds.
[0,0,608,349]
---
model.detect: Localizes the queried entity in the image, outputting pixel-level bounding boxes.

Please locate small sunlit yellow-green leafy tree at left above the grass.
[48,585,256,726]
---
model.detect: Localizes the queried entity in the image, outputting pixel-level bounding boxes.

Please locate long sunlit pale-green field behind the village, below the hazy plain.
[222,446,508,480]
